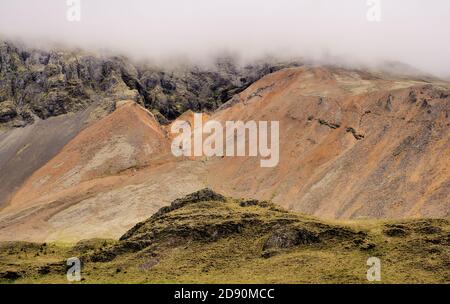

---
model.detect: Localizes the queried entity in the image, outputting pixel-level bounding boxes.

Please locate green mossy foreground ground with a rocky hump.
[0,189,450,283]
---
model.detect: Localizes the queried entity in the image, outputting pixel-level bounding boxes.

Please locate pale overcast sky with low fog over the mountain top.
[0,0,450,76]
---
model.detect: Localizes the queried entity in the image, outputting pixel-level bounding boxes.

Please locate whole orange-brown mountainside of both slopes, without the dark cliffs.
[0,62,450,241]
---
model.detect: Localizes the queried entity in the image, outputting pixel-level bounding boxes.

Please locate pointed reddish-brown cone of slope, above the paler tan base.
[4,102,168,207]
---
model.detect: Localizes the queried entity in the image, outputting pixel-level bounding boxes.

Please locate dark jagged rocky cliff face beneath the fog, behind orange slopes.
[0,42,298,127]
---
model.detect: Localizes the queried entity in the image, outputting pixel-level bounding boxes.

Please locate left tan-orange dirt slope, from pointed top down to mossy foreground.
[0,102,207,241]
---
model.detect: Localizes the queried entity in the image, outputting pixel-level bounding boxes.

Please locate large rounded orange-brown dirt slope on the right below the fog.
[209,67,450,219]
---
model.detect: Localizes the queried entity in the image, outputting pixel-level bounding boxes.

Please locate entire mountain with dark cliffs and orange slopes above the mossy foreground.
[0,43,450,242]
